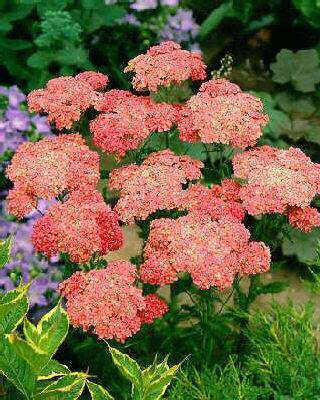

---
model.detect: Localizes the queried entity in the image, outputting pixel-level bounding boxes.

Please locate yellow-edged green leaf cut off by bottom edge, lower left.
[33,373,86,400]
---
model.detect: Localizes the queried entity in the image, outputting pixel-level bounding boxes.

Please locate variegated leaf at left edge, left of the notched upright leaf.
[0,285,29,336]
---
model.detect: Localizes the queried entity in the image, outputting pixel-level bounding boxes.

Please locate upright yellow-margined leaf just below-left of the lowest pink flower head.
[25,303,69,361]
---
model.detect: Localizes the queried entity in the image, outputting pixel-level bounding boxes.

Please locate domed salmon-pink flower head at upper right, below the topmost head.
[178,79,268,149]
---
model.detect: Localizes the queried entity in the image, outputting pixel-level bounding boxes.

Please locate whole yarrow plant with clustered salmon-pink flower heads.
[7,42,320,343]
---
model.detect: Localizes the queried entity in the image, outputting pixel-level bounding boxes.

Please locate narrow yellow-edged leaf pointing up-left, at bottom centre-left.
[109,346,142,387]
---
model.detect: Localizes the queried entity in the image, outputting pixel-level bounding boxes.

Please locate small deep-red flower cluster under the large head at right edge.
[287,206,320,232]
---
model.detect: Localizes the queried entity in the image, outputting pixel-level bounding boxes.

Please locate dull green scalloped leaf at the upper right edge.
[270,49,320,93]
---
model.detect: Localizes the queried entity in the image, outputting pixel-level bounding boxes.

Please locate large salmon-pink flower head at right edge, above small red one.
[232,146,320,227]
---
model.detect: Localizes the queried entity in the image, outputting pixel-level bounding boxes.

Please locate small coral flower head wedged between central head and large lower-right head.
[179,184,245,221]
